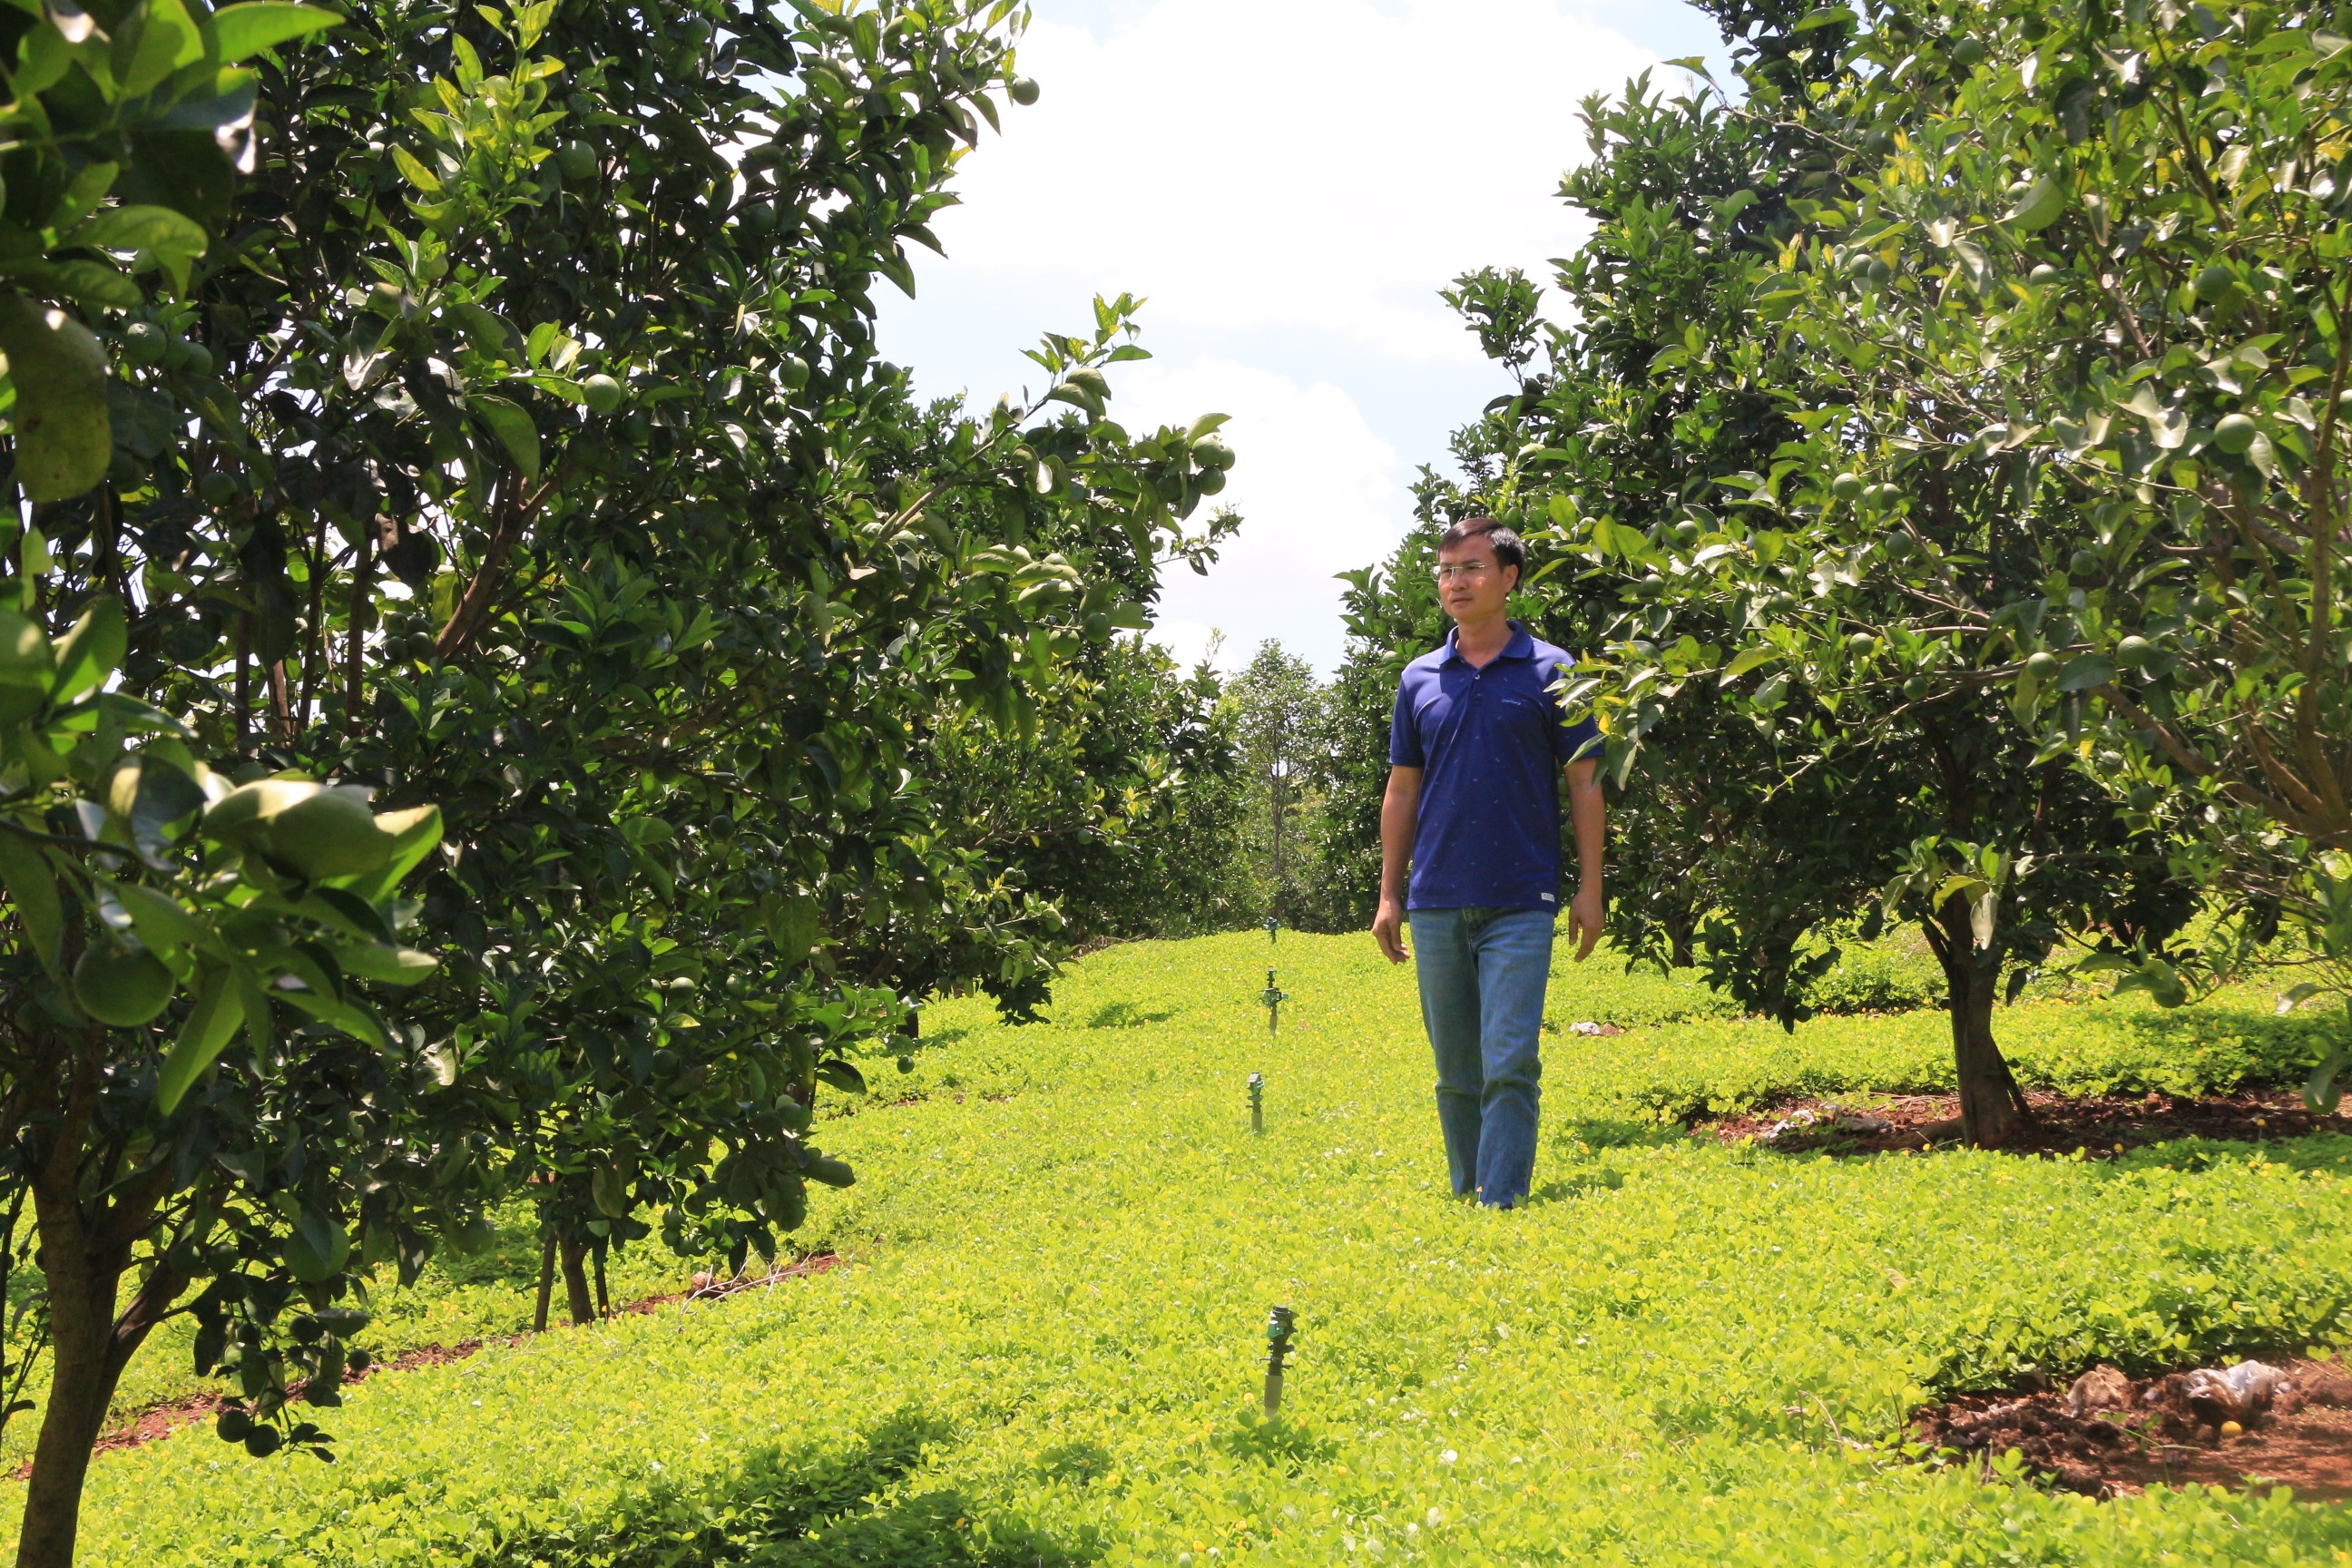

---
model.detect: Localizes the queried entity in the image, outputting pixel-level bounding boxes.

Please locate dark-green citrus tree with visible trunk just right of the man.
[1383,5,2192,1142]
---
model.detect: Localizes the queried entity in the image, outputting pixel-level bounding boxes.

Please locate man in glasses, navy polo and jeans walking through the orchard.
[1371,517,1604,1209]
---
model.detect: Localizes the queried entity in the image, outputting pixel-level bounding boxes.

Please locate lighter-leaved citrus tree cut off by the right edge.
[1740,5,2352,1098]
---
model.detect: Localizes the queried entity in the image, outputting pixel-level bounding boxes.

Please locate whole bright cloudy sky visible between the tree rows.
[882,0,1721,672]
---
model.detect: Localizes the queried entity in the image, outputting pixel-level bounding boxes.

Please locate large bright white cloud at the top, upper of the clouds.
[938,0,1649,362]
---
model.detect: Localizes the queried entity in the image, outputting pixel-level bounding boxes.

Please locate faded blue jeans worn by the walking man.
[1406,910,1553,1209]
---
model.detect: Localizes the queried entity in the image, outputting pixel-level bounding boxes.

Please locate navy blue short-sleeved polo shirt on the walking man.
[1387,621,1600,910]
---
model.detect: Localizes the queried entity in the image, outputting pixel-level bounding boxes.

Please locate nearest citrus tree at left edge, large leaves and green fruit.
[0,0,461,1565]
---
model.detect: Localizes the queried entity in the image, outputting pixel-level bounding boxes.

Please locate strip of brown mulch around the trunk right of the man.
[1691,1088,2352,1159]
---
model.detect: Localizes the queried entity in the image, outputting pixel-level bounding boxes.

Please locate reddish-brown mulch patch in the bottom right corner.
[1912,1361,2352,1502]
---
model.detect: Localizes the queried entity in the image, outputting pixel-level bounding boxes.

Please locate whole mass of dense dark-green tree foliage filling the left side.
[0,0,1232,1563]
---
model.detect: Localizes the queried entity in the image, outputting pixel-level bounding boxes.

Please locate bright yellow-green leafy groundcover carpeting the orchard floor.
[36,936,2352,1568]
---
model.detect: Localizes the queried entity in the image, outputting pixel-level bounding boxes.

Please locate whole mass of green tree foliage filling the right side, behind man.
[1326,0,2343,1142]
